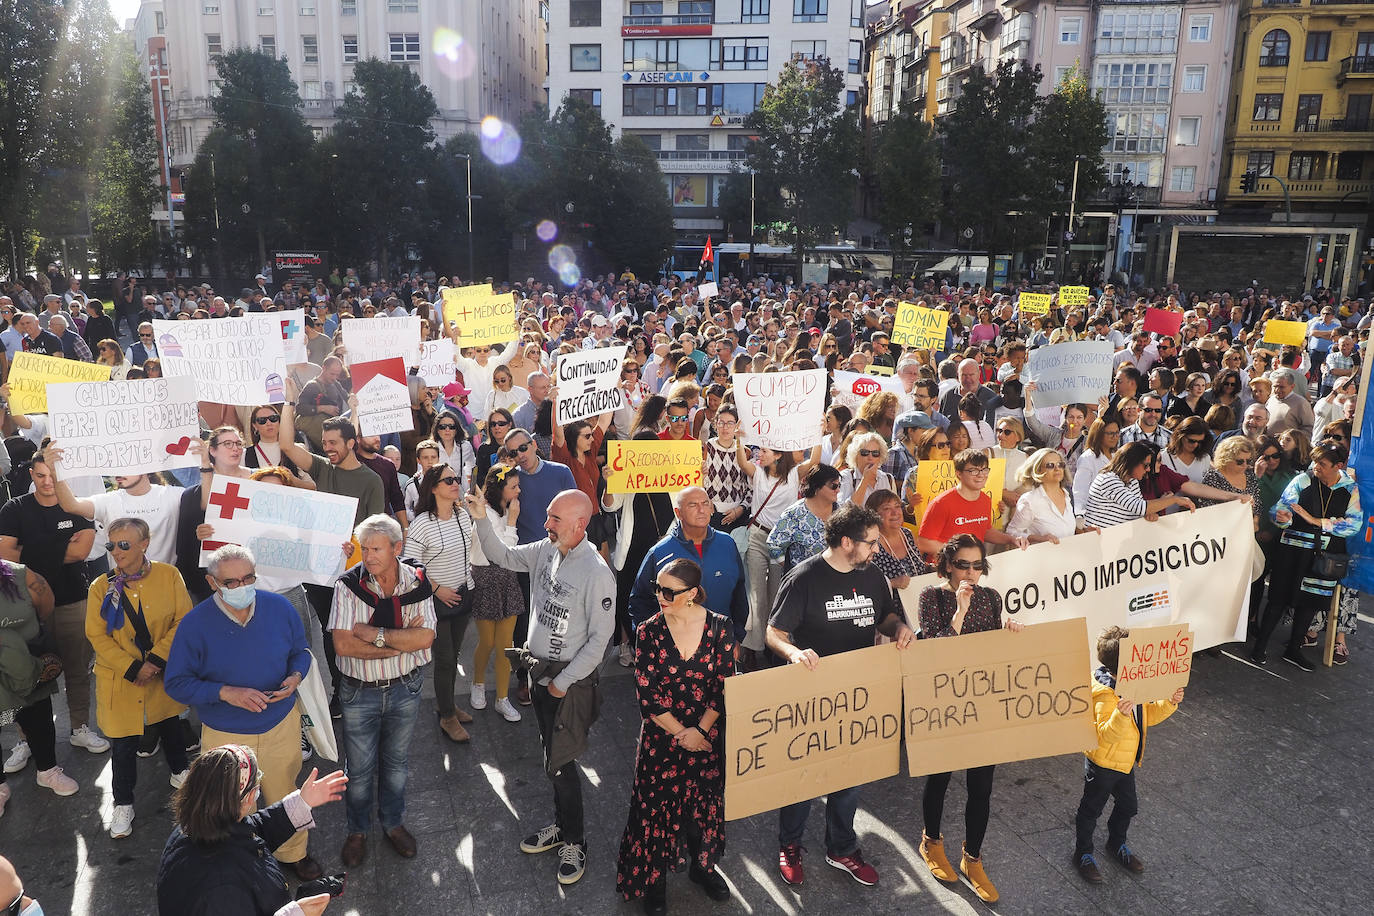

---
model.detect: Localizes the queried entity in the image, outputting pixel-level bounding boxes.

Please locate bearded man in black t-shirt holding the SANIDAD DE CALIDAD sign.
[768,504,915,886]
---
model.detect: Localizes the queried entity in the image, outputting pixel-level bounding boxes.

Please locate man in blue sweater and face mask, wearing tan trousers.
[165,544,324,882]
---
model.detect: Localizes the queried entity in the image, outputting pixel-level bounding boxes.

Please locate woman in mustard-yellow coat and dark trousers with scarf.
[87,518,191,839]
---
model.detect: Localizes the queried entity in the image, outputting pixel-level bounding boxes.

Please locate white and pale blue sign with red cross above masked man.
[201,475,357,588]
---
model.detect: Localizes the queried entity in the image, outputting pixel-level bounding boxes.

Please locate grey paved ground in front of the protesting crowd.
[0,609,1374,916]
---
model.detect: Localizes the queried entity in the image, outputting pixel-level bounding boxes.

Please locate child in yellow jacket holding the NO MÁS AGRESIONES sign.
[1073,626,1183,884]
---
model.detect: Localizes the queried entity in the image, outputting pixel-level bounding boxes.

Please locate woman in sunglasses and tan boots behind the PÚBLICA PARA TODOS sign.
[918,534,1024,904]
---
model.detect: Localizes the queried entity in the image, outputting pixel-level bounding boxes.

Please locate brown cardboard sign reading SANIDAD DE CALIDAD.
[725,645,910,820]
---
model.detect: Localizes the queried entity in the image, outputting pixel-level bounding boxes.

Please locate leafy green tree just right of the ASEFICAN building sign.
[745,60,860,279]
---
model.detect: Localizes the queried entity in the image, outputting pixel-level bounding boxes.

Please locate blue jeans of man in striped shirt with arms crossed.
[339,667,425,834]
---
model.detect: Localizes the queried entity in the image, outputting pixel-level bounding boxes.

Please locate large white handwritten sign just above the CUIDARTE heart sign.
[153,312,286,407]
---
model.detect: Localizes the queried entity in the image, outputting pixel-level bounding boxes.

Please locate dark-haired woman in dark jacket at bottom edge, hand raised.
[157,744,348,916]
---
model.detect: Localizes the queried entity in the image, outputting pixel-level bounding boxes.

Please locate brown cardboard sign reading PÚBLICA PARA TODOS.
[899,619,1098,776]
